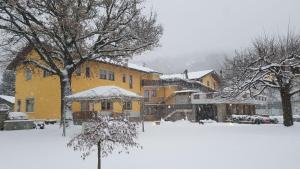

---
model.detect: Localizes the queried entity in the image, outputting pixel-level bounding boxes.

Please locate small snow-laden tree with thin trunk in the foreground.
[68,115,140,169]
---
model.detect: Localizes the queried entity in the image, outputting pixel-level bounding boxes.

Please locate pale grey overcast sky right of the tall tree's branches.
[134,0,300,72]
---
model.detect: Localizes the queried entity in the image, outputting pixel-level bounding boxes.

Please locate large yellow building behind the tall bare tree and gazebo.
[8,48,159,120]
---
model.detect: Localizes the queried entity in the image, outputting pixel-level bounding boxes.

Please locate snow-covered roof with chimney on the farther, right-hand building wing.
[160,69,214,79]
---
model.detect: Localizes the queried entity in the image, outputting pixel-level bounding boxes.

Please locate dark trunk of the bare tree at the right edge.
[280,88,293,127]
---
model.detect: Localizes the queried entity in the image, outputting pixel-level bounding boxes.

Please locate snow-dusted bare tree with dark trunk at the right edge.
[224,33,300,126]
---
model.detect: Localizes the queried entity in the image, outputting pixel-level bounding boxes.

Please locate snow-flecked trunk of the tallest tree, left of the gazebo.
[60,73,73,136]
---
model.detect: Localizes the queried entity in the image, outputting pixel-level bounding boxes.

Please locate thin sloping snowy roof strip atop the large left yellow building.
[97,58,159,73]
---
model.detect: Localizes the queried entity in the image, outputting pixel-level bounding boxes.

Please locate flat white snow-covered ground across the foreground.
[0,121,300,169]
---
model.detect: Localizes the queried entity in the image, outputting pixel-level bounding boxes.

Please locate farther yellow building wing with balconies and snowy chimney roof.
[142,70,220,120]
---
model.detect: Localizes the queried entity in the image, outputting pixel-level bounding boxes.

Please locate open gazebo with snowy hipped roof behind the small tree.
[67,86,143,124]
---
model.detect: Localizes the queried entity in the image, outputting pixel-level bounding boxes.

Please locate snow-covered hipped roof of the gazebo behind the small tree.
[67,86,142,101]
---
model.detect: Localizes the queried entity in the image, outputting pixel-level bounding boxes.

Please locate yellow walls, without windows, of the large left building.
[15,51,157,119]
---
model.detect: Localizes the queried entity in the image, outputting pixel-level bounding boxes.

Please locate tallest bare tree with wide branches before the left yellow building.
[0,0,162,135]
